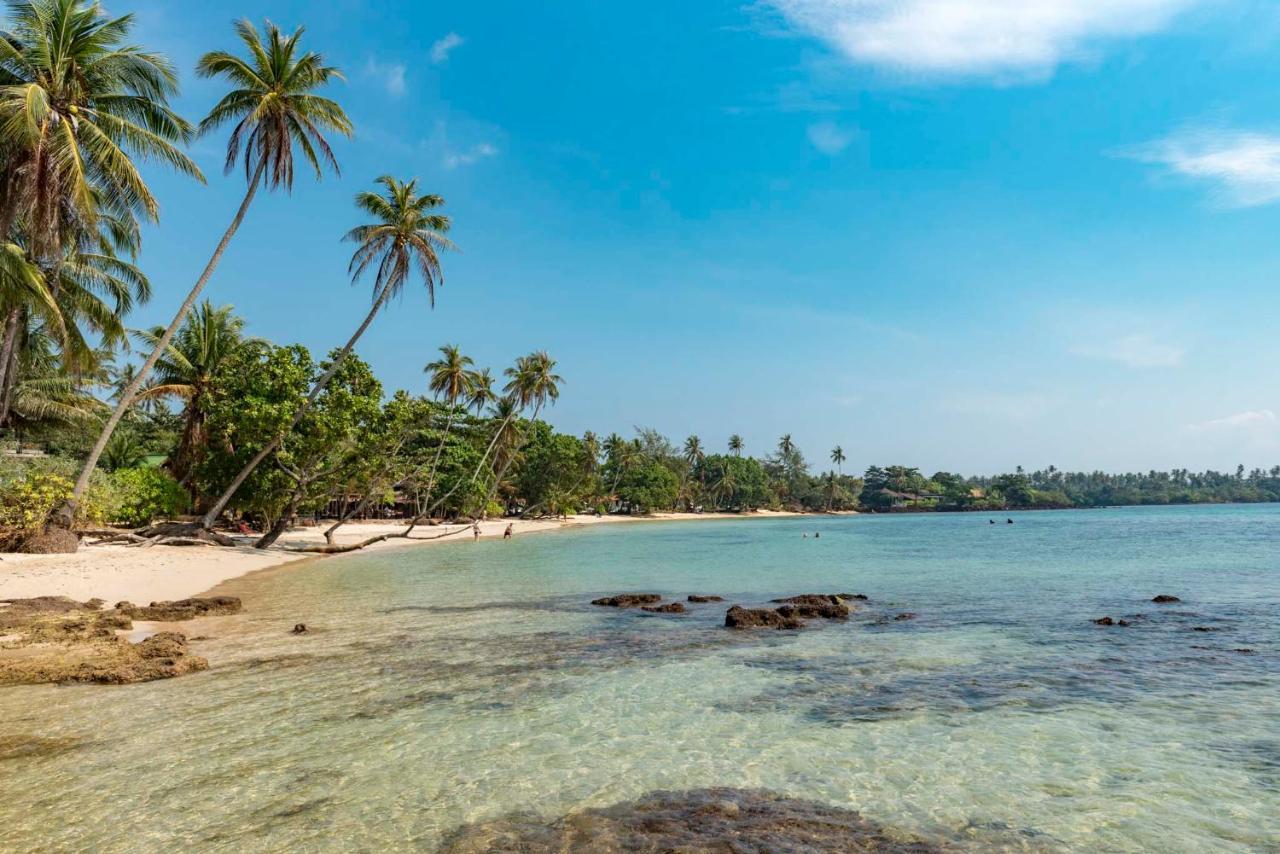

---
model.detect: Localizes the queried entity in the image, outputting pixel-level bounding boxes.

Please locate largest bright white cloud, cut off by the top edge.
[763,0,1203,77]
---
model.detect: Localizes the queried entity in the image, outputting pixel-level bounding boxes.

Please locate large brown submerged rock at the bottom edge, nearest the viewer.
[442,789,954,854]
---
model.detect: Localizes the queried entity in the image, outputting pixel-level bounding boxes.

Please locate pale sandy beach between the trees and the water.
[0,511,819,604]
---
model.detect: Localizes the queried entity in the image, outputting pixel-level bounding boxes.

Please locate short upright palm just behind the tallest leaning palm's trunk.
[131,300,246,499]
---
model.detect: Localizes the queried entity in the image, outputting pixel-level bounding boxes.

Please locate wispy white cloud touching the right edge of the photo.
[1120,128,1280,207]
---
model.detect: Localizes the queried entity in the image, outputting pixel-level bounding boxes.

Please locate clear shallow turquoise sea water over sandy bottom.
[0,506,1280,851]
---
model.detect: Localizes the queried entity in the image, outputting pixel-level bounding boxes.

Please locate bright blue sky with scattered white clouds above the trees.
[108,0,1280,474]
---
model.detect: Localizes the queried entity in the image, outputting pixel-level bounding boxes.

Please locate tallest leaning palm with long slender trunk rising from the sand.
[51,18,352,528]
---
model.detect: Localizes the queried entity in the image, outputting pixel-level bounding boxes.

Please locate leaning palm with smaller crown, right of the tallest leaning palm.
[201,176,454,530]
